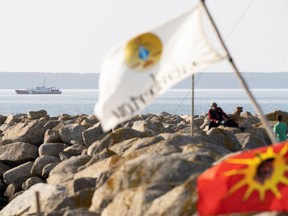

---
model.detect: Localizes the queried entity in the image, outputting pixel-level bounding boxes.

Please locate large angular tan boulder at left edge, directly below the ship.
[2,120,46,146]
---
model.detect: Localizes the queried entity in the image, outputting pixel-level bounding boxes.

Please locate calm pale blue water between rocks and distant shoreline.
[0,89,288,116]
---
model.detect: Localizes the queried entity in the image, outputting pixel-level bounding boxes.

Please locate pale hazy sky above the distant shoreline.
[0,0,288,72]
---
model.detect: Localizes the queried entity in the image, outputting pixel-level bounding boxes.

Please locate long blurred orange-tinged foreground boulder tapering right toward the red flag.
[90,154,210,213]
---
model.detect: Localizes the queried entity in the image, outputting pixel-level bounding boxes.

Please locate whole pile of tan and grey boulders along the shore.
[0,110,280,216]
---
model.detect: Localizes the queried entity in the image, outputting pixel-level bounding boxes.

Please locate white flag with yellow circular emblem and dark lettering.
[95,4,223,131]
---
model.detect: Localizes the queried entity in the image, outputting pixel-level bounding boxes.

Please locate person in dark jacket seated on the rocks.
[208,102,229,129]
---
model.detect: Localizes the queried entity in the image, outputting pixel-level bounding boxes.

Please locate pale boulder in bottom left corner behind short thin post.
[0,183,66,216]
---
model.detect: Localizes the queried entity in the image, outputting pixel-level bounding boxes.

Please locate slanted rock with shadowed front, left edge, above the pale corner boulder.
[3,161,33,184]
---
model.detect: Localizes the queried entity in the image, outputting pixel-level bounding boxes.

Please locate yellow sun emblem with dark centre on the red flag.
[224,144,288,201]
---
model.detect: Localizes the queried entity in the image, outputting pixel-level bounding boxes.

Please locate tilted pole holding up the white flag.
[201,0,276,143]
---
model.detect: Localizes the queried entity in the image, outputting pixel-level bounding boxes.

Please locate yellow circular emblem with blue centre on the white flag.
[125,33,162,71]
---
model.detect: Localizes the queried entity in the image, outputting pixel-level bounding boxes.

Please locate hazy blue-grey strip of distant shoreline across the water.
[0,72,288,89]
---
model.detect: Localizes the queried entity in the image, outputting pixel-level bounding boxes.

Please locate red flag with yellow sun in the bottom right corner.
[197,141,288,215]
